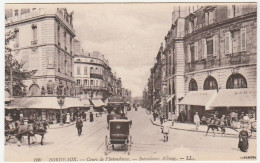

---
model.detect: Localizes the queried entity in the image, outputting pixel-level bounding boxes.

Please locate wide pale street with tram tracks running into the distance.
[5,108,256,161]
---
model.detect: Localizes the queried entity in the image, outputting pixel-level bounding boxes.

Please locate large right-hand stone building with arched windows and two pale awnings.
[180,4,257,121]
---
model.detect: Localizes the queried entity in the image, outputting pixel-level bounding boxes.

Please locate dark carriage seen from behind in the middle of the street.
[105,119,132,154]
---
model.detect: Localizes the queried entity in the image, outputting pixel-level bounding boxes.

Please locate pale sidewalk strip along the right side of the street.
[151,118,256,139]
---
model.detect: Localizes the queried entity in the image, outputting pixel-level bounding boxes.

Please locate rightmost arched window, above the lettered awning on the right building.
[226,74,247,89]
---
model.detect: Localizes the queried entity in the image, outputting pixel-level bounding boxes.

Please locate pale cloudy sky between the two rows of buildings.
[70,3,173,97]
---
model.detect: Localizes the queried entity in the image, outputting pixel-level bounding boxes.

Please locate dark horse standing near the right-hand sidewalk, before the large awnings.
[201,116,225,136]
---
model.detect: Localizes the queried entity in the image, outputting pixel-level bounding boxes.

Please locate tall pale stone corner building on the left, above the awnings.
[5,8,75,96]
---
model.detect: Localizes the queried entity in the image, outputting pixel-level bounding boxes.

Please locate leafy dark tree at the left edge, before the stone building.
[5,29,36,96]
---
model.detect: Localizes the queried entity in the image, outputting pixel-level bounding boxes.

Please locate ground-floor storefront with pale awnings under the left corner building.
[6,97,86,123]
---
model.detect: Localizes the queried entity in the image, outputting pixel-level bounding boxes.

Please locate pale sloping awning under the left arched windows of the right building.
[179,90,217,110]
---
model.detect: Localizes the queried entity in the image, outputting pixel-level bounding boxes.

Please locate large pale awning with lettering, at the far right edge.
[210,88,257,107]
